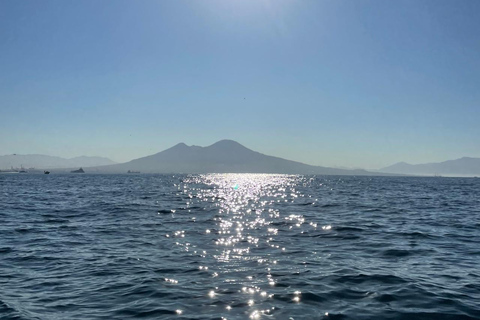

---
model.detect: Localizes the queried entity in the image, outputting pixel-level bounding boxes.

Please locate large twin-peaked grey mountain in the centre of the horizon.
[89,140,388,175]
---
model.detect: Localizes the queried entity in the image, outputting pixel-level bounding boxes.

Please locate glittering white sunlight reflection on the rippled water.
[174,174,322,319]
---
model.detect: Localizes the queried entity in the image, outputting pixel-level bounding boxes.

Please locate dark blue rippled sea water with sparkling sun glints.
[0,174,480,320]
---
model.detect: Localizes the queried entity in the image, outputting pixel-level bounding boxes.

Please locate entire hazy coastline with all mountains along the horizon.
[0,140,480,177]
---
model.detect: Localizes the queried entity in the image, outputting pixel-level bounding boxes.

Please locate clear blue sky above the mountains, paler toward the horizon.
[0,0,480,169]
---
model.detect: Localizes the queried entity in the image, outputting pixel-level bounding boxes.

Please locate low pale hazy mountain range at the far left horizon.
[0,154,116,170]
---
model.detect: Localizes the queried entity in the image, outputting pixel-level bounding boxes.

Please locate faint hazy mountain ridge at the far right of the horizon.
[379,157,480,176]
